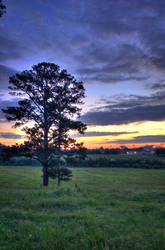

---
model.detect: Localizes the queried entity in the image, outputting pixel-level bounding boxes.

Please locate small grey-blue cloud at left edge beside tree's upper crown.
[0,65,16,92]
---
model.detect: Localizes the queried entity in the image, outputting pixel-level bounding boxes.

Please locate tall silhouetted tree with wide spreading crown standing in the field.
[2,62,86,186]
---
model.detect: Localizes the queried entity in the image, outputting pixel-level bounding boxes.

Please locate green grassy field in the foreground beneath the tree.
[0,166,165,250]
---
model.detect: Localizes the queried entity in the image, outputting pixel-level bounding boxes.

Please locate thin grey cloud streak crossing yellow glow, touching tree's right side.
[73,131,138,138]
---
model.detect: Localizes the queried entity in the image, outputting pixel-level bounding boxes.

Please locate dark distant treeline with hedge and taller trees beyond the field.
[0,145,165,169]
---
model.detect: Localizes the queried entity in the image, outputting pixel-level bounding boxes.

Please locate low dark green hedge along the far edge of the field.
[0,155,165,169]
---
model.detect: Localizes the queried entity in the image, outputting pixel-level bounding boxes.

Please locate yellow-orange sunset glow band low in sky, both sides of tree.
[0,121,165,149]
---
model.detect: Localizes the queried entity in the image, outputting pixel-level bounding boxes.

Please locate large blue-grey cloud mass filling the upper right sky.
[71,0,165,83]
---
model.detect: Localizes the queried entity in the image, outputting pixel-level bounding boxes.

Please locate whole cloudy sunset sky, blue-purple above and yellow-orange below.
[0,0,165,148]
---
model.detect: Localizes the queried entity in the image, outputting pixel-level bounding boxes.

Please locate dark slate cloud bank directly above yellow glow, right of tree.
[81,92,165,125]
